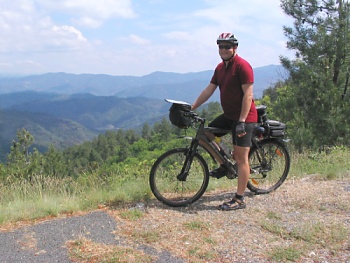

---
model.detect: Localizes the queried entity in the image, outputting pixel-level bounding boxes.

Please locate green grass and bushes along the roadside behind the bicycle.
[0,123,350,223]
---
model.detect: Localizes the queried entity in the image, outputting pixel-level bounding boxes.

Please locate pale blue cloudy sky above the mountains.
[0,0,292,76]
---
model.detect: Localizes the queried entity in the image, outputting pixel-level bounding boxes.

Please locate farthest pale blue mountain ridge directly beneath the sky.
[0,65,284,101]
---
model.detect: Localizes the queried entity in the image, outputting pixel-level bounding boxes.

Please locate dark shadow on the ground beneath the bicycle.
[148,191,255,214]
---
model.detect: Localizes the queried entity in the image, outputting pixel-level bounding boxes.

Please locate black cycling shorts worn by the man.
[208,114,256,147]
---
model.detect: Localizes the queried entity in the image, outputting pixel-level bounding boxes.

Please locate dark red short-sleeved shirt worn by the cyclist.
[210,55,258,122]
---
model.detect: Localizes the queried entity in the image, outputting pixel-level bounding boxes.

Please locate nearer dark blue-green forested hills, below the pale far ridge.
[0,95,170,160]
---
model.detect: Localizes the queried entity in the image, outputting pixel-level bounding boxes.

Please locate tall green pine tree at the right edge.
[274,0,350,147]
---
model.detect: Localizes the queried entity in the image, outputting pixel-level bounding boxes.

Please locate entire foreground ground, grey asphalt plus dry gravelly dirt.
[0,175,350,263]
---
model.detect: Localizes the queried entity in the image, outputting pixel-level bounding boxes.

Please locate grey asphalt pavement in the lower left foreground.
[0,211,184,263]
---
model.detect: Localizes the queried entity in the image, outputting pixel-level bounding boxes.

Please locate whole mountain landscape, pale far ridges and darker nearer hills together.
[0,65,283,160]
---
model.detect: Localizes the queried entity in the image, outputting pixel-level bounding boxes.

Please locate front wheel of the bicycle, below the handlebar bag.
[149,148,209,207]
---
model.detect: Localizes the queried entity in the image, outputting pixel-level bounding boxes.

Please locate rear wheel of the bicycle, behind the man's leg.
[247,139,290,194]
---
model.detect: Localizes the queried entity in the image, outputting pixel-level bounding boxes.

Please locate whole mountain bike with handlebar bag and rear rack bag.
[149,99,290,207]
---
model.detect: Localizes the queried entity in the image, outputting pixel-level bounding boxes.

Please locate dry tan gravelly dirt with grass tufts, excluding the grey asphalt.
[110,175,350,262]
